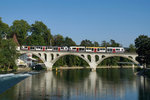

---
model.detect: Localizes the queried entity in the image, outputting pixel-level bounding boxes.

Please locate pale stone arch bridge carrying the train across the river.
[19,50,139,70]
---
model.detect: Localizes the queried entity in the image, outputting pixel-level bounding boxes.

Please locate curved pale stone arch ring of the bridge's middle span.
[52,53,89,67]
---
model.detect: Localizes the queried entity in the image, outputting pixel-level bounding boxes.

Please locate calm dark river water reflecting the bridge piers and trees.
[0,69,150,100]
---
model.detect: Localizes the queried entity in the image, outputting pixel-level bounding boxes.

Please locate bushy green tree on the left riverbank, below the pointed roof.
[0,39,18,70]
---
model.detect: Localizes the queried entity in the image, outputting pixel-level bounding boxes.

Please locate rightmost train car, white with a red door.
[107,47,125,53]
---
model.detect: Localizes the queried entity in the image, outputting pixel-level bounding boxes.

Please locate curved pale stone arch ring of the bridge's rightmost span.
[97,55,139,64]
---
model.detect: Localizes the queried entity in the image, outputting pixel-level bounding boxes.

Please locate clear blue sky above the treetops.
[0,0,150,47]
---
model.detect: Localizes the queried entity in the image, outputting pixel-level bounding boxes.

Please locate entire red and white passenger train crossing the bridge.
[21,46,125,53]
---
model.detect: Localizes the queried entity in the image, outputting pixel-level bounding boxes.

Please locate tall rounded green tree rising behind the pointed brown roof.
[9,20,30,45]
